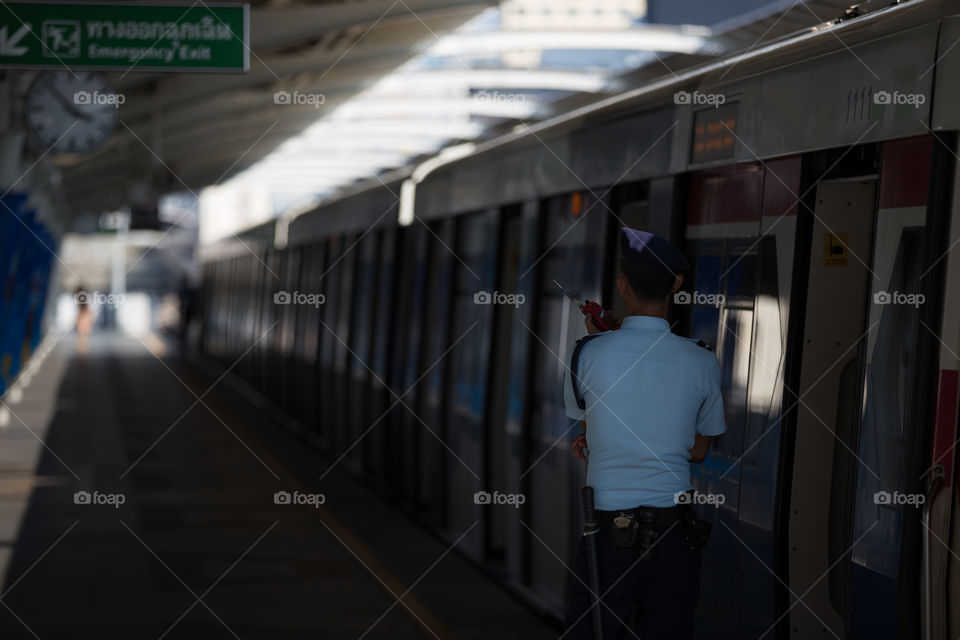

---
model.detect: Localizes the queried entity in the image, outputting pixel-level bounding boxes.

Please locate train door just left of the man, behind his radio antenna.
[520,192,609,614]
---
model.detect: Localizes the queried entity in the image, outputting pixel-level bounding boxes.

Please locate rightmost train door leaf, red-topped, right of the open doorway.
[846,136,944,640]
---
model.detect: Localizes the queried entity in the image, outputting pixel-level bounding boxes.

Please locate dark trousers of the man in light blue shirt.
[563,511,700,640]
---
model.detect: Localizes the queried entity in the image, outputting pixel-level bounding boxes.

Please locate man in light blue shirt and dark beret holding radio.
[564,227,726,640]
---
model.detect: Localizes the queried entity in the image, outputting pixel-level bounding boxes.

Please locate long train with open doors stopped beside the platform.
[200,0,960,640]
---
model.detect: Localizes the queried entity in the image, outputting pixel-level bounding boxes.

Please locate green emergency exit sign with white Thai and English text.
[0,2,250,72]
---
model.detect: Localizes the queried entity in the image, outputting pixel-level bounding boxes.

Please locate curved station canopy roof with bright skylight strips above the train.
[43,0,872,242]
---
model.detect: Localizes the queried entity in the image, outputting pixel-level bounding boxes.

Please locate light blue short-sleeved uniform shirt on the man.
[563,316,727,511]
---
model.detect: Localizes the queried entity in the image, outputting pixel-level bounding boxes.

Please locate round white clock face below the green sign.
[24,71,124,153]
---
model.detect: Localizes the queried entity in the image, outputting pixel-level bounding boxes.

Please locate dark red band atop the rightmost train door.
[880,136,933,209]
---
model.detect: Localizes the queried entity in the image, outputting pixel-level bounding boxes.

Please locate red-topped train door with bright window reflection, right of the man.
[684,156,801,640]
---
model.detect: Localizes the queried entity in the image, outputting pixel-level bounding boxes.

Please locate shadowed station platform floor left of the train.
[0,333,559,640]
